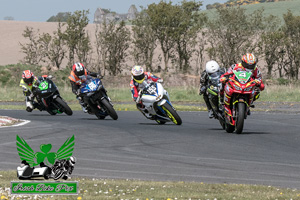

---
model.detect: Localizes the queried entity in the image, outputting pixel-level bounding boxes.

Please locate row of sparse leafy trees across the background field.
[21,1,300,79]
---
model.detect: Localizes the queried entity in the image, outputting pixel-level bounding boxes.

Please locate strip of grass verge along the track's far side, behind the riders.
[0,84,300,103]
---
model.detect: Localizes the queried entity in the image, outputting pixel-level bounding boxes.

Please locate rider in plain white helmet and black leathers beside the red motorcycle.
[199,60,225,118]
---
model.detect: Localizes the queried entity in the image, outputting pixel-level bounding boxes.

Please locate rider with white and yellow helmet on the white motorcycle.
[130,65,163,111]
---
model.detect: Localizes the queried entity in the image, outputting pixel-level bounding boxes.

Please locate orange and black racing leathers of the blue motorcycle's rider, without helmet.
[68,69,98,112]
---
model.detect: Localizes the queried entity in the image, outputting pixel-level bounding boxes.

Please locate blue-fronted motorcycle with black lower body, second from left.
[80,76,118,120]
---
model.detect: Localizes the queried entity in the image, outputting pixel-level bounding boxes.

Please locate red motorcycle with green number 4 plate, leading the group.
[224,70,257,134]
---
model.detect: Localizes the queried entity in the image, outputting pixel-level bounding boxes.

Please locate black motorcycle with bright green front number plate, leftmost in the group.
[36,77,73,115]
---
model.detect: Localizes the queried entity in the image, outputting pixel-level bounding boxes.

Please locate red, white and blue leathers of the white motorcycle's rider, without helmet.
[130,72,162,109]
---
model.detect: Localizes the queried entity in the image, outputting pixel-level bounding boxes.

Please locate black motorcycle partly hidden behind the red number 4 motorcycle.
[206,72,225,129]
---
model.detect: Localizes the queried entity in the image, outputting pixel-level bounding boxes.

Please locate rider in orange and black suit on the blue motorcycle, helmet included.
[69,62,99,112]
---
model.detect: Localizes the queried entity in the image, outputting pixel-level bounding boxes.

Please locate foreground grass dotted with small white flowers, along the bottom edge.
[0,169,300,200]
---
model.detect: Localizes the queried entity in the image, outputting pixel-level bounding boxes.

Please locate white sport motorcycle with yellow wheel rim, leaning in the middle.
[136,80,182,125]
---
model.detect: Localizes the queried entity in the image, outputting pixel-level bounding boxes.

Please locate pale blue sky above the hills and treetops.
[0,0,227,23]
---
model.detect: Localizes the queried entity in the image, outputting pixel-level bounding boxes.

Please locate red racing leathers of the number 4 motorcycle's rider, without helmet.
[220,63,265,108]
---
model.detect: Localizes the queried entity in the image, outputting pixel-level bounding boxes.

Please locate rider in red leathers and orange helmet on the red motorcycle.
[220,53,265,115]
